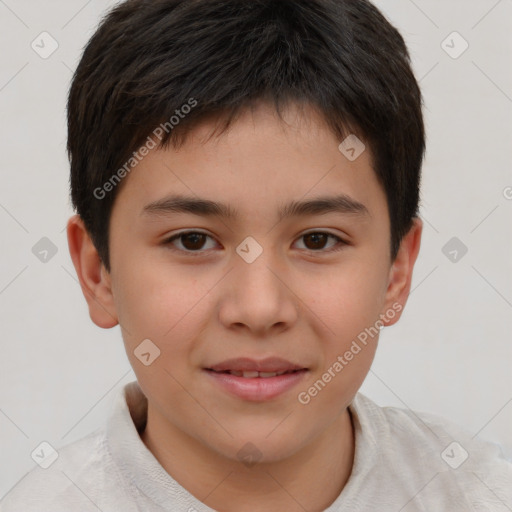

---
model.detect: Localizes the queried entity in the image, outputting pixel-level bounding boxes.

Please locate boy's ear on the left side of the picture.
[67,215,118,329]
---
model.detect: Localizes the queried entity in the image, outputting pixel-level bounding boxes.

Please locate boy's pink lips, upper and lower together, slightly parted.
[203,357,309,402]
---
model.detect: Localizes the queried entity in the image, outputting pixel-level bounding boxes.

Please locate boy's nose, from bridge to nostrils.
[219,251,300,337]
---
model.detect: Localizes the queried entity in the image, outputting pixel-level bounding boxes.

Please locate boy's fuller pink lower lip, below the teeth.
[204,370,308,402]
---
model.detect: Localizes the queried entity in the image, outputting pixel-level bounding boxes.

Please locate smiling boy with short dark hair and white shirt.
[2,0,512,512]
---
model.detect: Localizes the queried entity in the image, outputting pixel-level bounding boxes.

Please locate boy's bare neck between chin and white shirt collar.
[141,405,355,512]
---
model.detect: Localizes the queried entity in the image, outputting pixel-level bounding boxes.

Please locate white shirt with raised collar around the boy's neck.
[0,381,512,512]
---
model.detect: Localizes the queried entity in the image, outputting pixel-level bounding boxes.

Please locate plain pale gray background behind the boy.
[0,0,512,502]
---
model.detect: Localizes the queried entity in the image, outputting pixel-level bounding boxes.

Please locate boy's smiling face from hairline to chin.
[74,105,422,461]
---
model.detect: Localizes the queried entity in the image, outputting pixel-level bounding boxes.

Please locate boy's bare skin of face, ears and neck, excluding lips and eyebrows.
[68,104,422,512]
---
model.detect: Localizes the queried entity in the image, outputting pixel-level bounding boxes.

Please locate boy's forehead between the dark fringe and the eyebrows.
[110,105,385,224]
